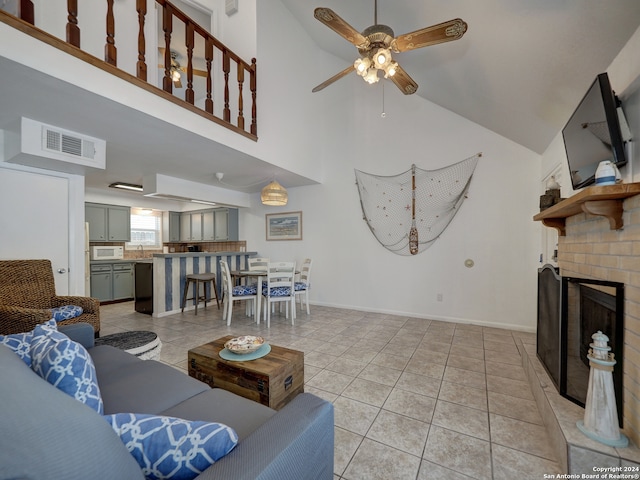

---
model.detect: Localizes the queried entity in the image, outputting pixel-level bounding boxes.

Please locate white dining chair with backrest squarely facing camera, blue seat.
[262,262,296,328]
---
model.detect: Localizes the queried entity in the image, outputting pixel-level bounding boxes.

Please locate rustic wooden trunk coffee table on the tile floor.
[188,335,304,410]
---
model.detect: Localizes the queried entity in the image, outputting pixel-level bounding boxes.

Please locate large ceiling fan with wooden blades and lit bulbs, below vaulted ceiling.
[312,0,467,95]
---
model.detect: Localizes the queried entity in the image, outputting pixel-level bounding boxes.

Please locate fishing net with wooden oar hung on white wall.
[355,153,482,255]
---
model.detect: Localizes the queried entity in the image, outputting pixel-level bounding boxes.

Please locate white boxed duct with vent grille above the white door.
[0,117,107,175]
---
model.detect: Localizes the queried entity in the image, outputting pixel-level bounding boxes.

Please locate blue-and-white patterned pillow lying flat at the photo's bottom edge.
[104,413,238,480]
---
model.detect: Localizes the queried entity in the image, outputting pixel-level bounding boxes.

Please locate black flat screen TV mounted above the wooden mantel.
[562,73,627,190]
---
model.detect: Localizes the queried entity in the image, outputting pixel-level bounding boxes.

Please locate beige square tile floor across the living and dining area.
[101,302,561,480]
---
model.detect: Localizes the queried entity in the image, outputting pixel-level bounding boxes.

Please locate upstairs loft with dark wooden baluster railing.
[0,0,258,141]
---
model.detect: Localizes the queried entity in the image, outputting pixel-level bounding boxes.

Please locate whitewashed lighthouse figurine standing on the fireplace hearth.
[576,330,629,447]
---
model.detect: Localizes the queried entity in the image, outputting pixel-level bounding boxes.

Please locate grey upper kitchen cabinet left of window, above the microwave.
[84,203,131,242]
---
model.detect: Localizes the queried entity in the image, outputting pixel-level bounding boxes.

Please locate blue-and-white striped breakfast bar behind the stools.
[152,252,256,317]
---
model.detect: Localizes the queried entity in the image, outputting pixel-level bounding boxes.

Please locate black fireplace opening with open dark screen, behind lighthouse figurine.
[537,265,624,427]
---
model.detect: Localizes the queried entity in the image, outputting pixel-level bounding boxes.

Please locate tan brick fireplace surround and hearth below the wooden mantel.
[521,191,640,472]
